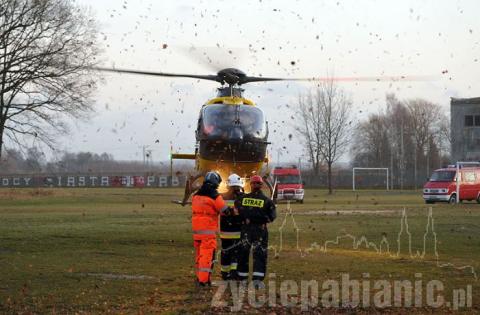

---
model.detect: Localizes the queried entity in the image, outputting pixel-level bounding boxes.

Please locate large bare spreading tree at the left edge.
[0,0,99,155]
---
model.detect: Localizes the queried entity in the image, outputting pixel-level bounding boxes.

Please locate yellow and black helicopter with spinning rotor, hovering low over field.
[95,68,428,205]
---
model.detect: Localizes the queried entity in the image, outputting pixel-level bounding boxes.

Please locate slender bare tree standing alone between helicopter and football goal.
[297,80,352,194]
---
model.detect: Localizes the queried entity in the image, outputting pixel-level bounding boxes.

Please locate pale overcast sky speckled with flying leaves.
[60,0,480,161]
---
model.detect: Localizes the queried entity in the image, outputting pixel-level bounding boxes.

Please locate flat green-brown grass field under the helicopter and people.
[0,189,480,314]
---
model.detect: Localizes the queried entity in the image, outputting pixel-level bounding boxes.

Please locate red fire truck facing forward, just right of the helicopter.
[272,165,304,203]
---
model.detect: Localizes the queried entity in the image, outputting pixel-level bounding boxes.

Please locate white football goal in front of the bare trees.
[352,167,390,191]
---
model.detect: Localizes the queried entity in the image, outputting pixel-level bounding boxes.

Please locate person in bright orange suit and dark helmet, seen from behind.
[192,172,230,287]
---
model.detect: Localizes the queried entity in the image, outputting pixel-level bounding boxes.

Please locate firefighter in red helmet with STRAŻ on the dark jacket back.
[237,175,277,288]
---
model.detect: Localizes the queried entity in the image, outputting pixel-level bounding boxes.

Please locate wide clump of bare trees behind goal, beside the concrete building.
[352,94,450,189]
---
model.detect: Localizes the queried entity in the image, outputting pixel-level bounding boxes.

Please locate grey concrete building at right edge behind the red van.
[450,97,480,162]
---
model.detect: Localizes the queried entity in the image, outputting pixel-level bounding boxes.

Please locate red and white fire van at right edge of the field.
[423,165,480,203]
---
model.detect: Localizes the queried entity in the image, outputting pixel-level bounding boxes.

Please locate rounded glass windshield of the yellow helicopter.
[199,104,268,142]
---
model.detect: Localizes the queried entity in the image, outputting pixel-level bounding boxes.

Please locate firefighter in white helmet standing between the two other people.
[220,174,243,280]
